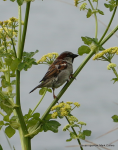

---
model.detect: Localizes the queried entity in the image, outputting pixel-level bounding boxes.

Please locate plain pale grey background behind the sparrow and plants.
[0,0,118,150]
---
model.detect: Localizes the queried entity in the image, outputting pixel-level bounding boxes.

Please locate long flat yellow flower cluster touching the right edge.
[93,47,118,60]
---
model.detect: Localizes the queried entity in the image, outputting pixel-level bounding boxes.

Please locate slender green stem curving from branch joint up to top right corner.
[98,1,118,44]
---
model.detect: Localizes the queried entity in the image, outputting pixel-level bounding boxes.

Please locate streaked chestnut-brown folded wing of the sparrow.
[41,59,67,81]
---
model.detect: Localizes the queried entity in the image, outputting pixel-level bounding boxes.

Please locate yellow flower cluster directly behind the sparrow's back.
[37,52,59,64]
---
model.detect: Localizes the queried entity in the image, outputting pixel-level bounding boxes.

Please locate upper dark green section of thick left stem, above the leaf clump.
[17,2,30,59]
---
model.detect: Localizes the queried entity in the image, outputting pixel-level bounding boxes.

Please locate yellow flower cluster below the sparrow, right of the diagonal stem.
[51,102,80,118]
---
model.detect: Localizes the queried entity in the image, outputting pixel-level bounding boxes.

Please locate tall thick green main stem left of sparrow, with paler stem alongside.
[15,2,31,150]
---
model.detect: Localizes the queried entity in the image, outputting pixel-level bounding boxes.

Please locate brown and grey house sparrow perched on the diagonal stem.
[30,51,78,99]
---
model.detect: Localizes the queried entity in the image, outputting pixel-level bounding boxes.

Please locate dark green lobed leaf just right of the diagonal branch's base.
[43,120,61,133]
